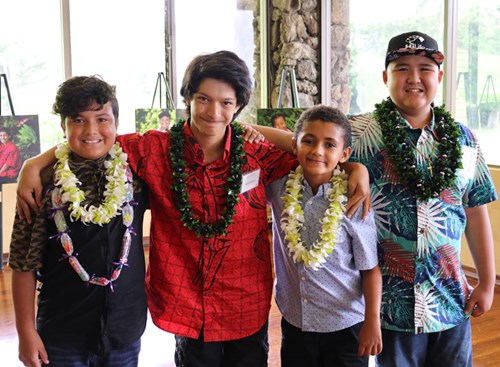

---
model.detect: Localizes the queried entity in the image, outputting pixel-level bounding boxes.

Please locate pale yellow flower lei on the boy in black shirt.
[54,142,128,225]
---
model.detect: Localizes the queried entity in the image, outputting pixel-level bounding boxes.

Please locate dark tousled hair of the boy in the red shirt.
[181,51,252,119]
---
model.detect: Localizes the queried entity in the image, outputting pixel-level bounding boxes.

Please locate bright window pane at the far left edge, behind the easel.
[0,0,63,149]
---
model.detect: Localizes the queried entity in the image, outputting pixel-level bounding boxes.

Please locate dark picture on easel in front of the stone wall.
[257,67,306,131]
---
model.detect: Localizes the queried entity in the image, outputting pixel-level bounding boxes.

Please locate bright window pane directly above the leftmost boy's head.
[70,0,165,133]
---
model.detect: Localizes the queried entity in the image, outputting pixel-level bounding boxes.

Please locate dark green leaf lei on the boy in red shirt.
[170,122,246,237]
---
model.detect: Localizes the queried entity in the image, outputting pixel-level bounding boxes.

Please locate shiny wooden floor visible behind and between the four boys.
[0,269,500,367]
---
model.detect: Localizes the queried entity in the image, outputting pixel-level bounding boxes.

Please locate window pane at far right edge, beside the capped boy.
[455,0,500,165]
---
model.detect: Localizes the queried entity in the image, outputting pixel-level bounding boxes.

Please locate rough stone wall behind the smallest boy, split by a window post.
[264,0,351,112]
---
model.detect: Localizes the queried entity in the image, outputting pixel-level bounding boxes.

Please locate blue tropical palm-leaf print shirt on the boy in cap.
[350,110,497,333]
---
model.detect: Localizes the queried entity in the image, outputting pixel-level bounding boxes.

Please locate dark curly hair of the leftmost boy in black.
[52,75,119,122]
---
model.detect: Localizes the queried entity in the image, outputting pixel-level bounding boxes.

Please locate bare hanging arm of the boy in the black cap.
[464,205,496,317]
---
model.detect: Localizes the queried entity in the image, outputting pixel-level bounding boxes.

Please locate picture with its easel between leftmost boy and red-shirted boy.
[135,72,186,134]
